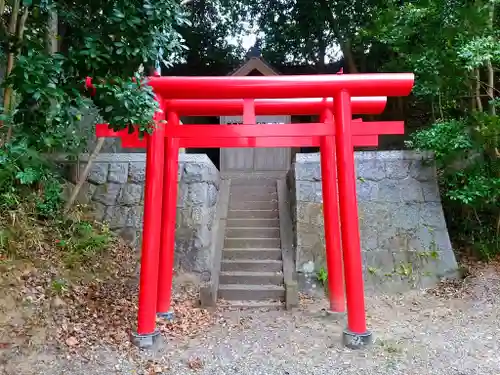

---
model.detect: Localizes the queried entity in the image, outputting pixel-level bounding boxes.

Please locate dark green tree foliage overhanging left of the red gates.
[0,0,189,214]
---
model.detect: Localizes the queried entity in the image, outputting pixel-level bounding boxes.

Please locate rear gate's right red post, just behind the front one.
[320,104,345,313]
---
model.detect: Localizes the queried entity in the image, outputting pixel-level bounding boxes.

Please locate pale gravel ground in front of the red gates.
[0,268,500,375]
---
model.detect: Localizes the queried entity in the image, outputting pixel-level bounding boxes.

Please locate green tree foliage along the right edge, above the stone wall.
[371,0,500,257]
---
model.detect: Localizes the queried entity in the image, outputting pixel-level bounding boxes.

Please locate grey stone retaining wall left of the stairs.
[64,153,220,278]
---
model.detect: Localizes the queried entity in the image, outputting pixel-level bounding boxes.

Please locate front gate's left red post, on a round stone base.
[132,97,165,347]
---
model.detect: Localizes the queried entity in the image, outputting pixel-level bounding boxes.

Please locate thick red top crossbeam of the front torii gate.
[148,73,414,99]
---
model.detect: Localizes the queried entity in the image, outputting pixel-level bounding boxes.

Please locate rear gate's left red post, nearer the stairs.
[157,112,179,320]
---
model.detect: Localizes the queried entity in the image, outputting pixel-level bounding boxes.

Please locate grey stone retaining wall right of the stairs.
[289,151,458,289]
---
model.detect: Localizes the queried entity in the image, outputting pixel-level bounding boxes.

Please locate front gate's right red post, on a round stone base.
[334,90,371,348]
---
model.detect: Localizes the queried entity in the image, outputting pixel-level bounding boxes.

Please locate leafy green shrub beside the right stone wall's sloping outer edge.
[408,112,500,258]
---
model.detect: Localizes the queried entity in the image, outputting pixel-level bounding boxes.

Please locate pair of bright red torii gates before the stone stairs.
[96,73,414,348]
